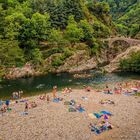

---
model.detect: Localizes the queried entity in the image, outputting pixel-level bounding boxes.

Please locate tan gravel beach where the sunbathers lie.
[0,89,140,140]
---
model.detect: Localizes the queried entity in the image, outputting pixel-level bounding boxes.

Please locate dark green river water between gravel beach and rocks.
[0,70,140,99]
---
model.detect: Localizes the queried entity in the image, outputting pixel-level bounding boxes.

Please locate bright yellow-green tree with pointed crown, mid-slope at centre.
[65,16,84,45]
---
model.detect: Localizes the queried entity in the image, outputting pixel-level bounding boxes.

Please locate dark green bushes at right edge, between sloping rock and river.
[120,51,140,72]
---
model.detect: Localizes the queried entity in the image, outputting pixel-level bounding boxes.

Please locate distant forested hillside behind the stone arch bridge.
[99,0,140,39]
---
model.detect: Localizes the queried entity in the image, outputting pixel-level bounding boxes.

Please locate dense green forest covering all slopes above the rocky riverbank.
[0,0,140,77]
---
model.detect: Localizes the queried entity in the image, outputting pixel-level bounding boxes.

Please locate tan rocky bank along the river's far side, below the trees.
[4,42,140,79]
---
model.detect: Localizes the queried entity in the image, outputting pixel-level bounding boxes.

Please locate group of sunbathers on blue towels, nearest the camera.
[89,121,113,134]
